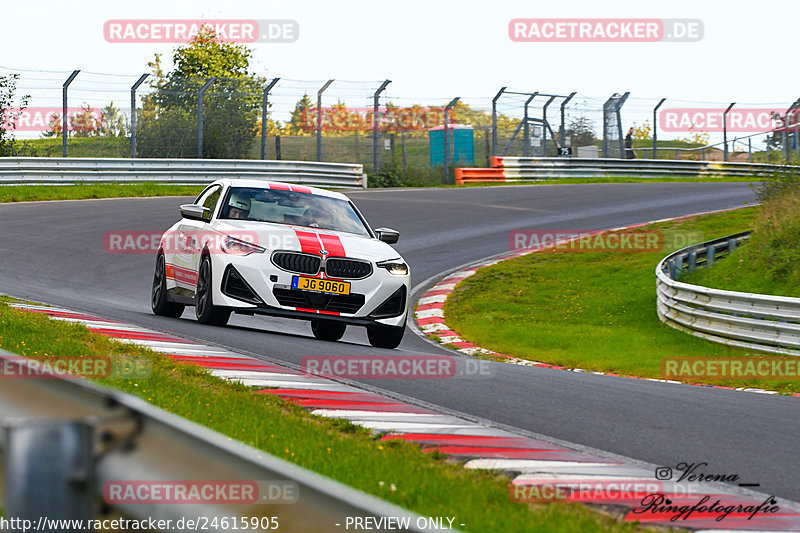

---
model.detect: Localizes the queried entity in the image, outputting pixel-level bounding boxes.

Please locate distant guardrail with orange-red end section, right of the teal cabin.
[456,157,798,184]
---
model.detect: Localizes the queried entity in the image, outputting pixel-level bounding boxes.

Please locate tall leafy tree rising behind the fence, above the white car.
[137,28,266,158]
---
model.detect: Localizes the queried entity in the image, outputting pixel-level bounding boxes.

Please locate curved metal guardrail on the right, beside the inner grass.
[656,232,800,355]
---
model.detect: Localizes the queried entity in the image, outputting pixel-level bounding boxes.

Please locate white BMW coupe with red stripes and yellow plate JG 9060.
[151,179,411,348]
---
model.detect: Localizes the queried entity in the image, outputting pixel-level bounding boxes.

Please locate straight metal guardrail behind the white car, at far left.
[0,157,367,188]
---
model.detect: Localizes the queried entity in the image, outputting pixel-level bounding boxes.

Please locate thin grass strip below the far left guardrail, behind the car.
[0,183,203,203]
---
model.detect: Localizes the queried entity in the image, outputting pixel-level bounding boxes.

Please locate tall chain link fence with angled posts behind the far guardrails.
[0,67,800,185]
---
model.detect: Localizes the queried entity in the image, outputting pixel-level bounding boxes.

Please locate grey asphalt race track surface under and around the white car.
[0,183,800,501]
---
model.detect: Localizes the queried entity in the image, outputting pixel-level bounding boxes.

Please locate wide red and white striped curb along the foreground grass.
[9,302,800,531]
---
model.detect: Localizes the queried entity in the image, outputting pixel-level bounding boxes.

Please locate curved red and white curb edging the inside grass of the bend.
[414,208,800,397]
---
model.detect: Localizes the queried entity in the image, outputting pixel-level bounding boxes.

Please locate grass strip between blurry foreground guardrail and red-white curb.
[0,298,643,532]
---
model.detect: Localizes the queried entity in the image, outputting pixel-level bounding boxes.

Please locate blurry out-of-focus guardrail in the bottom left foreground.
[0,350,432,532]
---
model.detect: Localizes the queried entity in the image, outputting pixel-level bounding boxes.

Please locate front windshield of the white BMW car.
[219,187,369,237]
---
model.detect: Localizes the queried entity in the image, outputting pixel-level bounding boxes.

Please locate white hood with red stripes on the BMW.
[214,220,400,261]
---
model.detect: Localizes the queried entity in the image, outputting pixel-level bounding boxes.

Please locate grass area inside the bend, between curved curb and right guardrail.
[444,207,800,393]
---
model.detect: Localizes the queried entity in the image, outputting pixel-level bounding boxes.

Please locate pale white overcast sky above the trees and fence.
[0,0,800,141]
